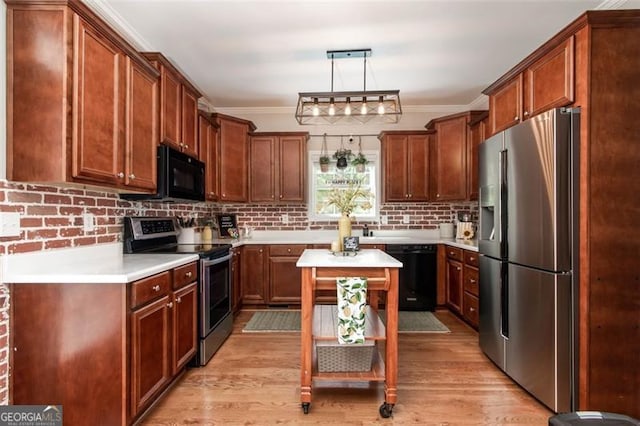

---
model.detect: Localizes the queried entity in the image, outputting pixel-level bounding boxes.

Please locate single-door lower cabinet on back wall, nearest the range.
[242,244,269,305]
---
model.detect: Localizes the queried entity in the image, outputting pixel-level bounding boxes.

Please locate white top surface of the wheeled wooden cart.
[296,249,402,268]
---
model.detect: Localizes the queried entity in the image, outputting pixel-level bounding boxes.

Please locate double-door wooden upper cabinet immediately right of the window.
[378,131,433,202]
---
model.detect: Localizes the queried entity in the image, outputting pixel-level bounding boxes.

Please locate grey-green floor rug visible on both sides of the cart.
[242,310,450,333]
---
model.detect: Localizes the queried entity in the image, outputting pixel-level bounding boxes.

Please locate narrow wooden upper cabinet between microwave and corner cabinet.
[198,111,220,201]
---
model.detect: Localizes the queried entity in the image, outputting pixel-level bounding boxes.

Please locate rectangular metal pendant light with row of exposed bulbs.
[296,49,402,125]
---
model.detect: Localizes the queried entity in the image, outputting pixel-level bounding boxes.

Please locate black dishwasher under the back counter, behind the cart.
[387,244,438,311]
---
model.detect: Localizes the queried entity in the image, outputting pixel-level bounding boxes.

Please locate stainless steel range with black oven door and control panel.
[124,216,233,366]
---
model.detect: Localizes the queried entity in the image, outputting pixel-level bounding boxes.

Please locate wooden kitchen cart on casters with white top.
[296,249,402,418]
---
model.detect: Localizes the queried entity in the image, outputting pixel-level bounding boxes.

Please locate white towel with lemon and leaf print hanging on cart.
[336,277,367,344]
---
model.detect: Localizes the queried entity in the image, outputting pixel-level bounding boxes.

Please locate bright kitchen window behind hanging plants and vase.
[308,151,380,222]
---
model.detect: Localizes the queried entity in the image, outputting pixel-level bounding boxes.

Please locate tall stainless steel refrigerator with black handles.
[478,108,580,412]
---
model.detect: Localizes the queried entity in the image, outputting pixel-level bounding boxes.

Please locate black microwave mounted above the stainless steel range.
[120,145,205,202]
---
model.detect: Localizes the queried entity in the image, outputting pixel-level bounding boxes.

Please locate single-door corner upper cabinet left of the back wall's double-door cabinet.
[211,113,256,202]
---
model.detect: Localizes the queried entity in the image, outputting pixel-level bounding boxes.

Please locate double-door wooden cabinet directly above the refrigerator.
[483,36,575,133]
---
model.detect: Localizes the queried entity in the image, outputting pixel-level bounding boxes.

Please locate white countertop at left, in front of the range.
[0,243,198,284]
